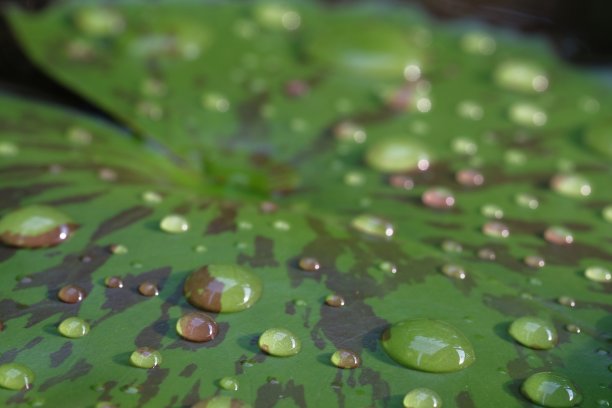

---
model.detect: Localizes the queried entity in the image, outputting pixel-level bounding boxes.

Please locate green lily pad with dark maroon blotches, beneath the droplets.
[0,0,612,408]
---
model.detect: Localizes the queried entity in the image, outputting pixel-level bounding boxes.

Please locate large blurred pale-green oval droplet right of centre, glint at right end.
[365,138,430,173]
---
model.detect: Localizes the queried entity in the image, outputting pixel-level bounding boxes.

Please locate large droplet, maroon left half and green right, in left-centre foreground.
[184,265,262,313]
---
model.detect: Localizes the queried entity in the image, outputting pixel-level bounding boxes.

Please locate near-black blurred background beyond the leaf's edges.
[0,0,612,113]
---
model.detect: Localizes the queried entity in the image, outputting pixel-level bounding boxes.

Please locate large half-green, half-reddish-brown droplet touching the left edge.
[0,205,77,248]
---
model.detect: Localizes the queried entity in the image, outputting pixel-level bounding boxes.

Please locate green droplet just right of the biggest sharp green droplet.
[508,316,558,350]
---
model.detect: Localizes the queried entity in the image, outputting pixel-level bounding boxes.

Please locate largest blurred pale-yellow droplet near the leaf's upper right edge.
[493,60,548,93]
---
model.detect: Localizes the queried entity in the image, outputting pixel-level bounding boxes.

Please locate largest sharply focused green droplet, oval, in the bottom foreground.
[382,319,476,373]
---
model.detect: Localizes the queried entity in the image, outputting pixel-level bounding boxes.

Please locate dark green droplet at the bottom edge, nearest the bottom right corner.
[521,372,582,408]
